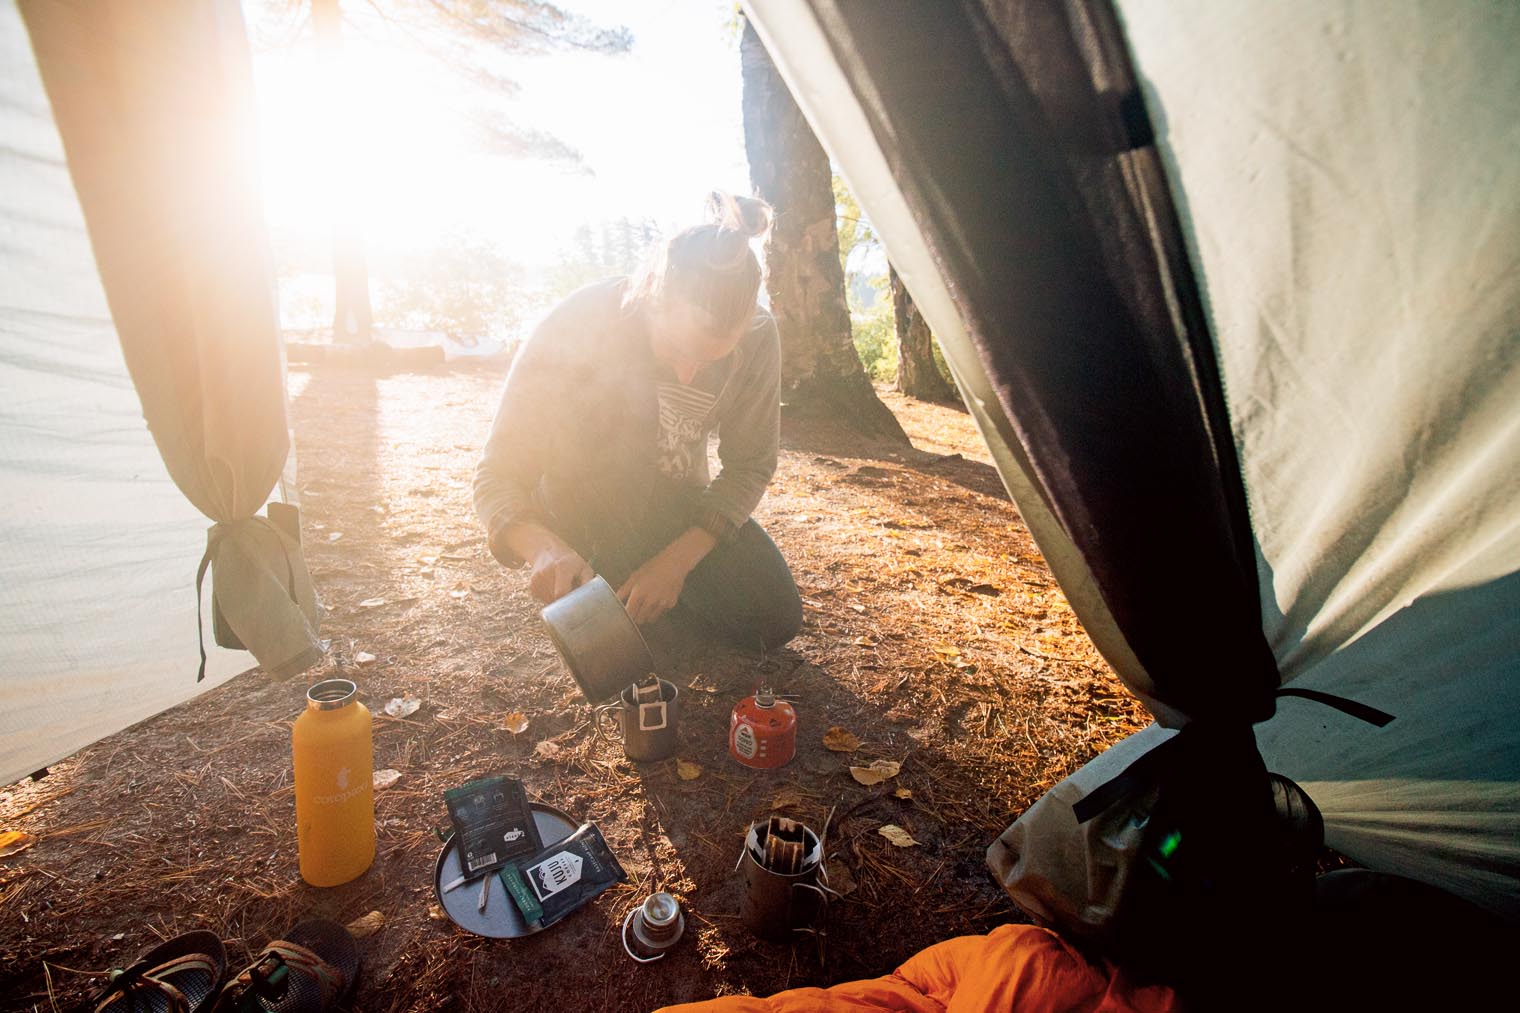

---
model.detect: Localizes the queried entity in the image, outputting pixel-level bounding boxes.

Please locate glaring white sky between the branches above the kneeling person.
[245,0,749,272]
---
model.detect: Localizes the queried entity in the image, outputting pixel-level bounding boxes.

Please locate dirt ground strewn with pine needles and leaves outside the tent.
[0,364,1148,1011]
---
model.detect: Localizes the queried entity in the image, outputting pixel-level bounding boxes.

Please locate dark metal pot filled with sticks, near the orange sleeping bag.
[739,817,828,943]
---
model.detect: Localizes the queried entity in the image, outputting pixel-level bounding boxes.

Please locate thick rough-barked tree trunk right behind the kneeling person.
[739,23,907,443]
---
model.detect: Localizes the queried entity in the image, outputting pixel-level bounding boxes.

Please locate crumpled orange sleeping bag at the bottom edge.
[658,925,1178,1013]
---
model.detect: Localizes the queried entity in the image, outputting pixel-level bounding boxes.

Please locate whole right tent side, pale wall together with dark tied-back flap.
[746,0,1520,917]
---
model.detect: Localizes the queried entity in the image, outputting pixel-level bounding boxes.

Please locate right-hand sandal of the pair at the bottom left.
[211,920,359,1013]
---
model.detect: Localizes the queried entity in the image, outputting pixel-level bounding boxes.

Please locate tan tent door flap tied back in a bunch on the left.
[21,0,321,677]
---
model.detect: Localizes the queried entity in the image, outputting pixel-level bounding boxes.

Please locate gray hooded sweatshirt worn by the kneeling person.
[474,278,781,566]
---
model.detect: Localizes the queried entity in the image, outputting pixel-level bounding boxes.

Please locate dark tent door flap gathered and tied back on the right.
[760,0,1277,719]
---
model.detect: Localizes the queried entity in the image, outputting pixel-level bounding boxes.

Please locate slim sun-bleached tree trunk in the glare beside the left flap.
[312,0,374,345]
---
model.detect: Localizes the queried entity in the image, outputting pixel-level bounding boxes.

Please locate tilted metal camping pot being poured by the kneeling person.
[538,576,655,704]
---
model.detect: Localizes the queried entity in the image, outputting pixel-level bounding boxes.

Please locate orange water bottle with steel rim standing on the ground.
[290,678,375,887]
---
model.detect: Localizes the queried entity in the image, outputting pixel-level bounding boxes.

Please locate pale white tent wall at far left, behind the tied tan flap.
[0,3,251,783]
